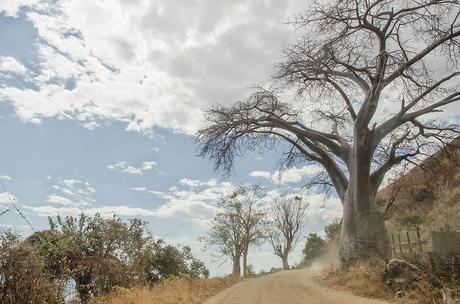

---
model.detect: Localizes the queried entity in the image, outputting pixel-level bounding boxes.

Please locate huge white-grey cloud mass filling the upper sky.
[0,0,310,134]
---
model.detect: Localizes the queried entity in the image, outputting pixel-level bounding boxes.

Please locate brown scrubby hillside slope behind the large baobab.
[377,137,460,231]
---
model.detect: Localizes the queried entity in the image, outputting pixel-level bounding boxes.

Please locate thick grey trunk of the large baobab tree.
[340,134,390,268]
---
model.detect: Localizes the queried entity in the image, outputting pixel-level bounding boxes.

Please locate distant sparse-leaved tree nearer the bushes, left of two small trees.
[200,186,265,276]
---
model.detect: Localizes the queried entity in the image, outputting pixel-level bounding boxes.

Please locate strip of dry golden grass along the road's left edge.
[91,277,240,304]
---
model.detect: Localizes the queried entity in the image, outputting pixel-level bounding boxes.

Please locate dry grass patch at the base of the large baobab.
[324,263,393,299]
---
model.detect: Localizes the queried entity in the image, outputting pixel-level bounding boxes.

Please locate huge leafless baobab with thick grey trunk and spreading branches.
[197,0,460,267]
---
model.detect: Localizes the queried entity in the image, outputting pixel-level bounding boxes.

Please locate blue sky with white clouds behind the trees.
[0,0,341,274]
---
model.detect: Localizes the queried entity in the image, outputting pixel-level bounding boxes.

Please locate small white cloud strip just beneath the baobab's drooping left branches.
[249,165,322,184]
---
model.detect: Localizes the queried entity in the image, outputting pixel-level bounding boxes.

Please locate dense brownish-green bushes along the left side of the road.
[0,214,209,304]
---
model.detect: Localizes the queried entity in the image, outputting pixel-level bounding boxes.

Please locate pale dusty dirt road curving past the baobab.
[206,269,386,304]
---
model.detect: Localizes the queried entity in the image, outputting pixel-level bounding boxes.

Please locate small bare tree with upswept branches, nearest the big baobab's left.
[268,196,309,269]
